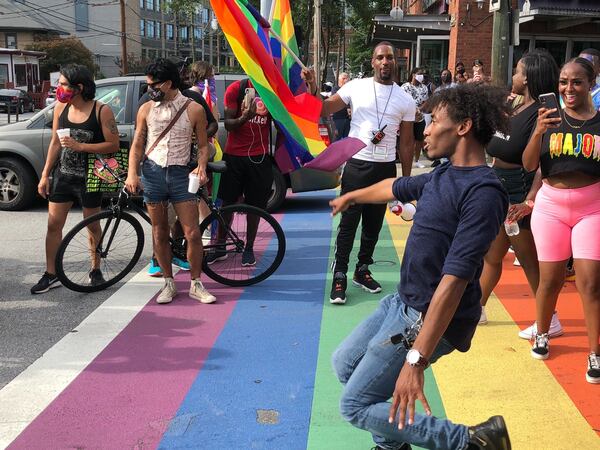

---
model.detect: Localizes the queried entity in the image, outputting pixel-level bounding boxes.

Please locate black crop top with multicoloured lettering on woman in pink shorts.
[540,110,600,178]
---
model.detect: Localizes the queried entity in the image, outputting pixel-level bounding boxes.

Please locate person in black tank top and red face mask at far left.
[31,64,119,294]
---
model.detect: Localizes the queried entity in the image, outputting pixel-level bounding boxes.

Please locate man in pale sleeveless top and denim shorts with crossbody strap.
[125,59,216,303]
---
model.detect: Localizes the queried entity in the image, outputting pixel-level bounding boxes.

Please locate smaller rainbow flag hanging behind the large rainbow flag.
[271,0,306,95]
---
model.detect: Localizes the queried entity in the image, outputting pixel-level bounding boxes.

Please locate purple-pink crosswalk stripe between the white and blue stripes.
[9,272,242,449]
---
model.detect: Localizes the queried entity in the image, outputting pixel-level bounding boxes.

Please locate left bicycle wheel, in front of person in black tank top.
[56,210,144,292]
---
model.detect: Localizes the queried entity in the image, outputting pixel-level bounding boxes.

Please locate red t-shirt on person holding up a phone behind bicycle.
[225,81,270,156]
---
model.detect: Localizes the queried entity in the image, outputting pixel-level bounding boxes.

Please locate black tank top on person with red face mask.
[58,101,104,178]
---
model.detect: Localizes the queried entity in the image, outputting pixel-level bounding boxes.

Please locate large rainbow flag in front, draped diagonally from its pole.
[211,0,325,169]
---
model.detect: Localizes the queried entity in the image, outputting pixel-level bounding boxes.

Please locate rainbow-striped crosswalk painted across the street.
[0,191,600,450]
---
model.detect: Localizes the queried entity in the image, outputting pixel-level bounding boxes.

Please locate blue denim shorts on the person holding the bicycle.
[142,159,196,203]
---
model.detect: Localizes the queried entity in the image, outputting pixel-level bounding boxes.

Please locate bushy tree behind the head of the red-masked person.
[26,37,98,80]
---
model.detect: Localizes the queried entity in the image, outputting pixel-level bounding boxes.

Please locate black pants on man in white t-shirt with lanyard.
[333,159,396,273]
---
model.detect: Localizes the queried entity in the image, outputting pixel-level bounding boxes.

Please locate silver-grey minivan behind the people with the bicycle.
[0,75,340,210]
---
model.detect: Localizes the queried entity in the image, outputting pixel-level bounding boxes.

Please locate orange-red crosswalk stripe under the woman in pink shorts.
[494,254,600,434]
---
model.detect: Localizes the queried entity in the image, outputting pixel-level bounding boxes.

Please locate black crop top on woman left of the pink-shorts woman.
[486,102,540,166]
